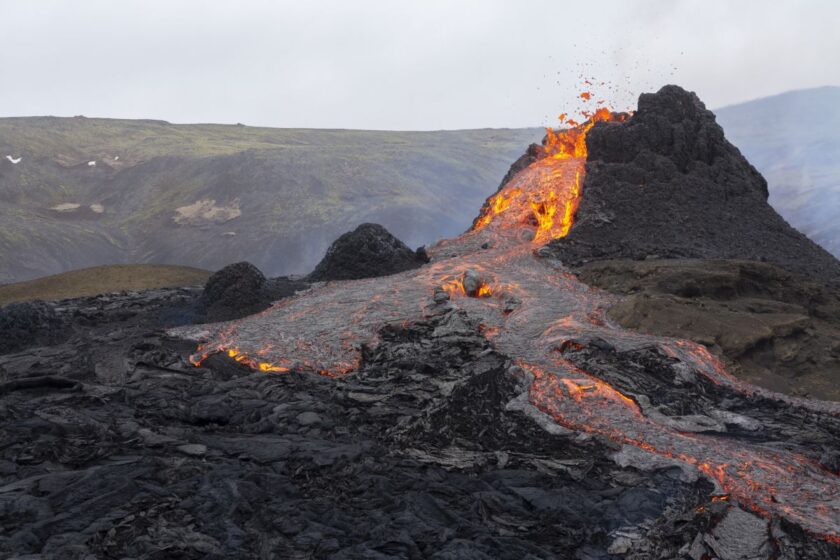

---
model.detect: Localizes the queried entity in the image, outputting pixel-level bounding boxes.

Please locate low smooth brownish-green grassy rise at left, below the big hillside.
[0,264,210,305]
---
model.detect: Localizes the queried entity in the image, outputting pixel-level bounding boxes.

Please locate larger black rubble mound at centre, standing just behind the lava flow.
[308,224,428,282]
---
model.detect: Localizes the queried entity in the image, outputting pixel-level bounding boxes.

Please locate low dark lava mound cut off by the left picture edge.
[0,301,69,354]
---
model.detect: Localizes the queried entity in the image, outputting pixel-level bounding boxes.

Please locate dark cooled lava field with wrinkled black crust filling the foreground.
[0,290,838,560]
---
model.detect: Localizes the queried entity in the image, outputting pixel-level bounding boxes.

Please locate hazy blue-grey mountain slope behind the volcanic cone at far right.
[715,87,840,257]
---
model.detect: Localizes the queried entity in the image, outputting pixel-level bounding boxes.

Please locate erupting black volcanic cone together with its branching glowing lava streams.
[176,86,840,556]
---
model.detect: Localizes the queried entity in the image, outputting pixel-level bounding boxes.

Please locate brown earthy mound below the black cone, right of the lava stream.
[578,259,840,400]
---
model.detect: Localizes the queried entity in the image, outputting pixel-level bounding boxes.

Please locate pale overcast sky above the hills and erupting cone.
[0,0,840,130]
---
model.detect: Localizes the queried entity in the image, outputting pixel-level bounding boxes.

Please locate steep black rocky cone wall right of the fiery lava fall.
[551,86,840,281]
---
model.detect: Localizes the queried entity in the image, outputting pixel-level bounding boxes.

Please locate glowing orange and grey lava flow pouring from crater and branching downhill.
[182,110,840,540]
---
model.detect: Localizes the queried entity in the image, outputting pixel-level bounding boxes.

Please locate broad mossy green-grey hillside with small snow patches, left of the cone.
[0,117,542,282]
